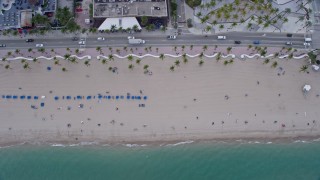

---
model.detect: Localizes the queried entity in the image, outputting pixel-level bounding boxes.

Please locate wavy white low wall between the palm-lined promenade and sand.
[7,53,309,61]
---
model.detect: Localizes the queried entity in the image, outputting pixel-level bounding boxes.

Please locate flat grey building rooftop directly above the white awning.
[93,0,168,18]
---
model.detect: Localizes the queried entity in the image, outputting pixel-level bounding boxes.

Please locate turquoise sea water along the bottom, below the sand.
[0,142,320,180]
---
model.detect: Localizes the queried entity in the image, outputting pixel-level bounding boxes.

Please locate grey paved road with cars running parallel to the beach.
[0,32,305,49]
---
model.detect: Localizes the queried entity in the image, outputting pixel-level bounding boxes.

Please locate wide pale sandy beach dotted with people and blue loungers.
[0,46,320,144]
